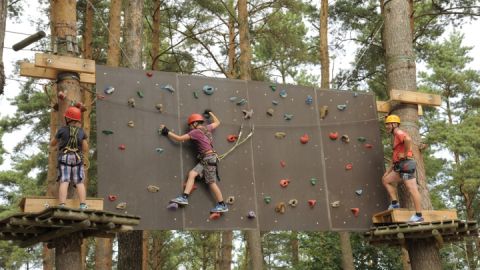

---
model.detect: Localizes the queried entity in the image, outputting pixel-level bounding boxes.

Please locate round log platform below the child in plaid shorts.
[0,206,140,247]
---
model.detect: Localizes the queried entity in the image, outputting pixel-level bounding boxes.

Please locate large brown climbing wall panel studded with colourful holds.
[96,66,387,231]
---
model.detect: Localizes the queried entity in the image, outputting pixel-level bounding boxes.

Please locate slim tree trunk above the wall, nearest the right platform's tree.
[320,0,330,89]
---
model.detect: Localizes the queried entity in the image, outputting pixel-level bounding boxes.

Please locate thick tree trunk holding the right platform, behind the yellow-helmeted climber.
[383,0,442,270]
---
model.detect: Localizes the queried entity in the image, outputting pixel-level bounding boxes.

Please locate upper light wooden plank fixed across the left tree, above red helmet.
[35,53,95,74]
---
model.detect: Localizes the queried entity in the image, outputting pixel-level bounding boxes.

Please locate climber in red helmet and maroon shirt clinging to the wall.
[160,110,228,213]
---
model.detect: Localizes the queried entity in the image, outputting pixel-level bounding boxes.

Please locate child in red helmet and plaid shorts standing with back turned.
[50,107,88,209]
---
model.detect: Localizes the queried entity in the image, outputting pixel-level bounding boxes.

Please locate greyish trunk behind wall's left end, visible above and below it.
[118,0,146,270]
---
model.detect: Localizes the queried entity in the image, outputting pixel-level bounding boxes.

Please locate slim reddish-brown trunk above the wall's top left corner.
[107,0,122,67]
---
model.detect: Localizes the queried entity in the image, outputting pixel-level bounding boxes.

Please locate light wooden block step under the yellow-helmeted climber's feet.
[372,208,458,224]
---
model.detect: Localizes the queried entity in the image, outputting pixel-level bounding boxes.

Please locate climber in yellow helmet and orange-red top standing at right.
[382,114,423,222]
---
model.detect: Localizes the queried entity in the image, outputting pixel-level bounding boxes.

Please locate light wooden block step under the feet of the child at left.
[20,196,103,213]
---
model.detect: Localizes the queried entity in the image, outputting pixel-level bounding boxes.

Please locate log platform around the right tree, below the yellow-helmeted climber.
[364,220,479,248]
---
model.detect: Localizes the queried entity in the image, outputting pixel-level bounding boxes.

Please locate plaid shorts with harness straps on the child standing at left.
[57,153,85,185]
